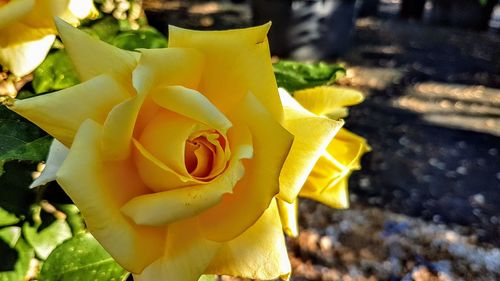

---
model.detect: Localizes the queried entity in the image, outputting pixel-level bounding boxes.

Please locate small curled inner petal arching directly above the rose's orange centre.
[153,86,232,134]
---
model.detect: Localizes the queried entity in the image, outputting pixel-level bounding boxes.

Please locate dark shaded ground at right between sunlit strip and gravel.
[347,96,500,245]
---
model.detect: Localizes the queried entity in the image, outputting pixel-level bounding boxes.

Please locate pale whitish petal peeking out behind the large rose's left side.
[30,139,69,188]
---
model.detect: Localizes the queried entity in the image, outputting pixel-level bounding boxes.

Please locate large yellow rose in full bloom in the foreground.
[11,20,294,281]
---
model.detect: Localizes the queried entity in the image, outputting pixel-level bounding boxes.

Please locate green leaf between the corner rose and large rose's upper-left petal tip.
[32,50,80,94]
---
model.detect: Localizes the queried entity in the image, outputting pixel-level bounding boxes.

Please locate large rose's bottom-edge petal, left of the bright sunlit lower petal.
[134,220,221,281]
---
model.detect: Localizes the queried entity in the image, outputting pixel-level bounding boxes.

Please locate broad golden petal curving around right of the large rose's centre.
[200,94,293,241]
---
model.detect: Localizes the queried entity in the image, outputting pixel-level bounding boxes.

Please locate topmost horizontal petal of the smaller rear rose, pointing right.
[293,86,364,116]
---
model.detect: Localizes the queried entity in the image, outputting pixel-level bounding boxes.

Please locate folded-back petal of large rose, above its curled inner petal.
[133,48,204,94]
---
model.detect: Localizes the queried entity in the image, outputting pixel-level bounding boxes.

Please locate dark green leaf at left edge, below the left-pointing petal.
[0,106,51,175]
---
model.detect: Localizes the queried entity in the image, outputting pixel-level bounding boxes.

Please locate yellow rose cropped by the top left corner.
[0,0,96,76]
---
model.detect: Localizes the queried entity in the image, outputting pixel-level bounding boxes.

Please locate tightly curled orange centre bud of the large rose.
[184,130,226,181]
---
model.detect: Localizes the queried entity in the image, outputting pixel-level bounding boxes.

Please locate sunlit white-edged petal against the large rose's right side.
[278,89,344,203]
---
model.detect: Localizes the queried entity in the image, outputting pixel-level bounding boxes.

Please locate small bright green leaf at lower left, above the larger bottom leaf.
[23,219,72,260]
